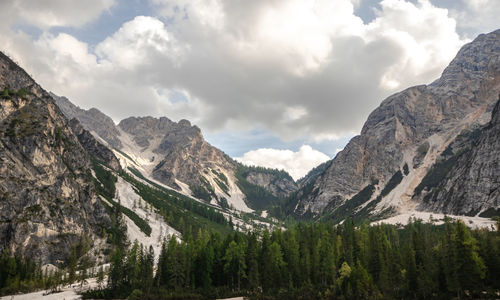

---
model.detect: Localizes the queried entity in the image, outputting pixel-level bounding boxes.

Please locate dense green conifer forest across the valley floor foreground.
[85,219,500,299]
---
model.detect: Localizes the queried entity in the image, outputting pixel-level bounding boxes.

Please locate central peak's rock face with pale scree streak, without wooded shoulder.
[118,117,243,205]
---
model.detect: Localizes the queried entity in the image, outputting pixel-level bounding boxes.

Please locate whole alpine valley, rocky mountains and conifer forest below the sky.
[0,30,500,299]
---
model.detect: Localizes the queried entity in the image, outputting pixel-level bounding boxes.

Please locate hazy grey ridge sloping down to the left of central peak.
[50,93,123,149]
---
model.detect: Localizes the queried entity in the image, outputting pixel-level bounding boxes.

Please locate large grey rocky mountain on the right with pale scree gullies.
[290,30,500,221]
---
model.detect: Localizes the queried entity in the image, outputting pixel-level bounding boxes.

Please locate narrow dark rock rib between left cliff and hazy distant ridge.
[69,119,121,171]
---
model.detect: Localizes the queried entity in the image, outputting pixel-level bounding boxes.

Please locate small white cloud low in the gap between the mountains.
[236,145,330,180]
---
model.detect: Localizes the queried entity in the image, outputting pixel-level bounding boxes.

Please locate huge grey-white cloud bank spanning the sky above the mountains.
[0,0,472,146]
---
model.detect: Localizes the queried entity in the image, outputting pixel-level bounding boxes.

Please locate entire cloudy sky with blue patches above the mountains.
[0,0,500,179]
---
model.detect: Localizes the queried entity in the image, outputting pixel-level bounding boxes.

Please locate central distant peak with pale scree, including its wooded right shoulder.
[118,117,296,211]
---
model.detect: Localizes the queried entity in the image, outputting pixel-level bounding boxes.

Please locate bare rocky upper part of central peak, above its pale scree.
[118,117,233,187]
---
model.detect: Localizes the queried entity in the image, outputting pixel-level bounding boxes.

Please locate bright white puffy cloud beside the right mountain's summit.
[366,0,465,90]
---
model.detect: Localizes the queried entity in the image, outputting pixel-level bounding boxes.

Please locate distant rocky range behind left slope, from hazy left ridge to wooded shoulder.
[53,95,297,212]
